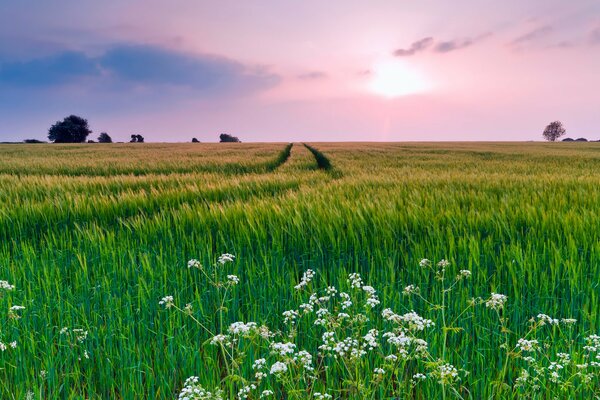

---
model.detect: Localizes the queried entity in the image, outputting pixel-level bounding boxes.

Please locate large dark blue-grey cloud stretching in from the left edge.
[0,44,279,96]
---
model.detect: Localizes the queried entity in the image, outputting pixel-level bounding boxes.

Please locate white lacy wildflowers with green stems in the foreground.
[169,254,600,400]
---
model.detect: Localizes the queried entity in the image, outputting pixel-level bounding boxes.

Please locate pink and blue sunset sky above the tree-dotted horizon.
[0,0,600,142]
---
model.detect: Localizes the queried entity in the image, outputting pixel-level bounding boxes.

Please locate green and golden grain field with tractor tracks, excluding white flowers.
[0,143,600,399]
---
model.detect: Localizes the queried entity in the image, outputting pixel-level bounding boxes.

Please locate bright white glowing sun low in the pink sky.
[367,60,431,98]
